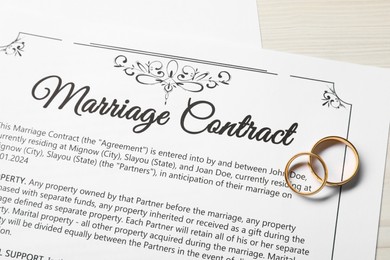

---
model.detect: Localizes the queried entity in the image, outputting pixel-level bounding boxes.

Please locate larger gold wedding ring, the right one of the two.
[309,136,360,186]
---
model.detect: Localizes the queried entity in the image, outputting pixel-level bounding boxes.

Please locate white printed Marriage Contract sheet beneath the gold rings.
[0,32,390,260]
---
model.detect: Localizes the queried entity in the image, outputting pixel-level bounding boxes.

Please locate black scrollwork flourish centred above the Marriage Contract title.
[114,55,231,104]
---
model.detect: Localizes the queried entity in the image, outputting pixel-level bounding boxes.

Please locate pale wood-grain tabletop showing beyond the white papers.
[257,0,390,260]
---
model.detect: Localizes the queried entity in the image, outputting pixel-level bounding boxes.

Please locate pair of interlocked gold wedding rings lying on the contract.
[284,136,360,196]
